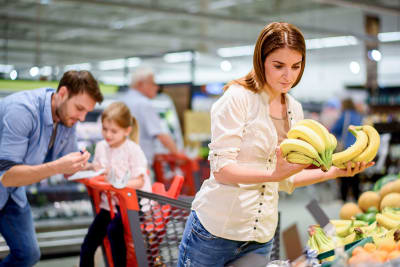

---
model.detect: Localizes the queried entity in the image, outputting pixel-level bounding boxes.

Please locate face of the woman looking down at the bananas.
[264,47,302,95]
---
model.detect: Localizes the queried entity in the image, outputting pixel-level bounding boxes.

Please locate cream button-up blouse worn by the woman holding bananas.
[192,85,303,243]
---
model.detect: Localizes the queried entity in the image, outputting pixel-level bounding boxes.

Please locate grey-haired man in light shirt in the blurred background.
[122,68,179,168]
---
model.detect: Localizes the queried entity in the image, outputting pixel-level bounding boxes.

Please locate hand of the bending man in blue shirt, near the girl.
[53,151,90,175]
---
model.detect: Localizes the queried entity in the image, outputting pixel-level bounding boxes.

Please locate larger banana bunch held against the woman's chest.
[280,119,337,171]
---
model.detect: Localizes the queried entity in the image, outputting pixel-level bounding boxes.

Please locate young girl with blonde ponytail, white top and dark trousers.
[80,102,151,267]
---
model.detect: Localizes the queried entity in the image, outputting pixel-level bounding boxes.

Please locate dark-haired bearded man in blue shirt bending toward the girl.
[0,71,103,266]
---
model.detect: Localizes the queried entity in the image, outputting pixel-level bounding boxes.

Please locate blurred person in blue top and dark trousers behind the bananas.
[331,98,363,201]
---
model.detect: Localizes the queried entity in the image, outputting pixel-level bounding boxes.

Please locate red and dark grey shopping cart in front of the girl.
[82,176,280,267]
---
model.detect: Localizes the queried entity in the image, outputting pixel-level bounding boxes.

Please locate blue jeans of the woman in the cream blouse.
[178,211,273,267]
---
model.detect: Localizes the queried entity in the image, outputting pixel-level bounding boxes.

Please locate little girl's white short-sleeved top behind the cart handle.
[93,139,151,212]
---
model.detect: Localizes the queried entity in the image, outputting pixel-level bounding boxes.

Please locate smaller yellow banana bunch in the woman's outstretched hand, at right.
[332,125,380,169]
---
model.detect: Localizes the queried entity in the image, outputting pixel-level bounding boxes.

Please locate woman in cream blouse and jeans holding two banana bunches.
[178,22,373,266]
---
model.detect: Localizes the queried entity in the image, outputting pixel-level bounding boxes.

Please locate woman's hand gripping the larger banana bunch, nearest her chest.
[272,147,310,181]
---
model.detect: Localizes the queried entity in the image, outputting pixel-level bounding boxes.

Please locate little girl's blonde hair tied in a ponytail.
[101,102,139,144]
